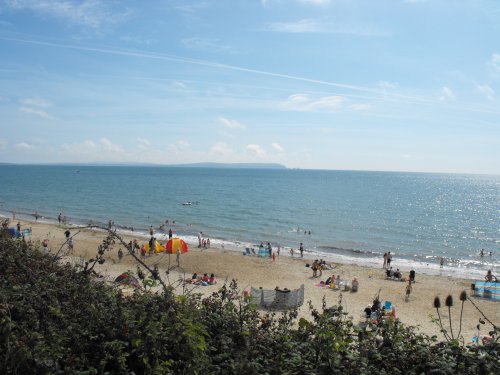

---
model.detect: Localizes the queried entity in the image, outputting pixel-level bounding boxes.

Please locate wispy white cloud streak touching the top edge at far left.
[5,0,131,29]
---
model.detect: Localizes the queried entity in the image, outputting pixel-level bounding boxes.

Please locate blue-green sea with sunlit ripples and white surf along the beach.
[0,165,500,278]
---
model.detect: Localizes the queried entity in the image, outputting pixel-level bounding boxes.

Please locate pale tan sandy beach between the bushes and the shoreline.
[10,221,500,342]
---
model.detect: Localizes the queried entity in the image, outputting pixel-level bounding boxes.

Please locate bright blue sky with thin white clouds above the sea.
[0,0,500,174]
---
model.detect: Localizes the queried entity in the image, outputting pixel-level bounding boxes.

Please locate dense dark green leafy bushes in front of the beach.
[0,238,500,374]
